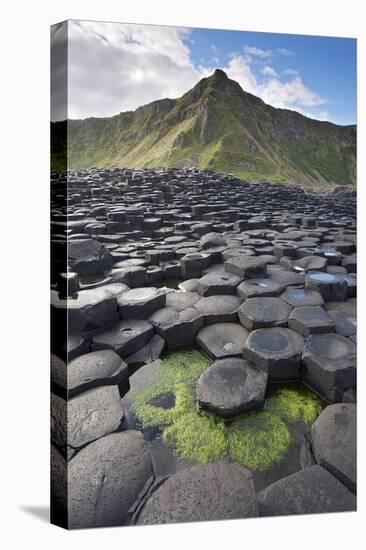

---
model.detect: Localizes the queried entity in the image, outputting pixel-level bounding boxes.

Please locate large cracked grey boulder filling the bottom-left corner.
[68,430,152,529]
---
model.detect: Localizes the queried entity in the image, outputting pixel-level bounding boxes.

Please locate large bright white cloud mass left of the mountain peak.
[64,21,211,118]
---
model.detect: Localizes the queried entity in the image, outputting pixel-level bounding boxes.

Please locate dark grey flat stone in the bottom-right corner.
[258,465,356,516]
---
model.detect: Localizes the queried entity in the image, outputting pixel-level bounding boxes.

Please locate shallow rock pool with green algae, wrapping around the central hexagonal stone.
[123,348,324,491]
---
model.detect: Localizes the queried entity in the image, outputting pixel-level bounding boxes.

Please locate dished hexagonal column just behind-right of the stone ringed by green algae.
[242,327,304,381]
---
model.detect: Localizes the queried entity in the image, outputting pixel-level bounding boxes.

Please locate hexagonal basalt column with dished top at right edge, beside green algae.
[302,334,356,402]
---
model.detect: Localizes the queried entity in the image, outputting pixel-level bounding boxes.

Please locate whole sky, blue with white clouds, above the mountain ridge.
[60,21,356,124]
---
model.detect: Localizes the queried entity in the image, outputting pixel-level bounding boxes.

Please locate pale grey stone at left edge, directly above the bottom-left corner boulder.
[67,386,123,449]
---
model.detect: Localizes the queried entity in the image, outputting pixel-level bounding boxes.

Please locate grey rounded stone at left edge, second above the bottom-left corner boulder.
[65,349,128,398]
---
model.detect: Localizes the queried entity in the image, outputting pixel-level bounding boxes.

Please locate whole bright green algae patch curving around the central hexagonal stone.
[132,350,323,471]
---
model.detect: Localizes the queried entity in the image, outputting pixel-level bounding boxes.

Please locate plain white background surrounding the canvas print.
[0,0,366,550]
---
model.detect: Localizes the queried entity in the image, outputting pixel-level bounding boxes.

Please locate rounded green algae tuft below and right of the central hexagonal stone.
[228,410,292,471]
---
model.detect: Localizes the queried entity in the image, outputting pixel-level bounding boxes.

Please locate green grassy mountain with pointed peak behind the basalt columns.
[52,69,356,184]
